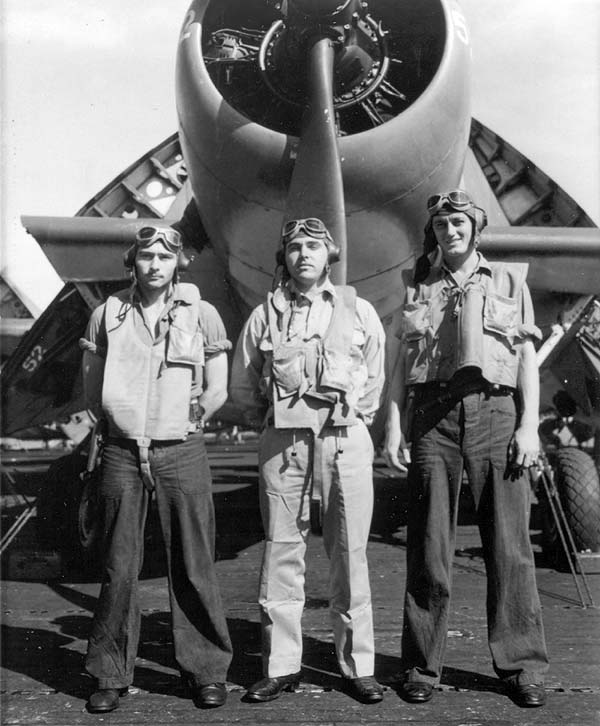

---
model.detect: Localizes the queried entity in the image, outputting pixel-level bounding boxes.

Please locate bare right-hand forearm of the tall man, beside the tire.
[510,339,540,467]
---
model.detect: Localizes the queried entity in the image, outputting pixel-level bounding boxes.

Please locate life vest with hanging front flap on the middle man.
[267,286,356,432]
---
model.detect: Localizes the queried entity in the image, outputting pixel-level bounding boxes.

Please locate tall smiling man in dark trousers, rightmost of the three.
[384,189,548,707]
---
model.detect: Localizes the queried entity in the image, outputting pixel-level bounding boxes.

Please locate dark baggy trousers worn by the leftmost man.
[86,433,232,688]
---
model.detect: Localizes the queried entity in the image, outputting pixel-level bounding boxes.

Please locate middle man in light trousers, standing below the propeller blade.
[231,217,385,703]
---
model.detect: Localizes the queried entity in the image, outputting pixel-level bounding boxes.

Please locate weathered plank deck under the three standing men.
[1,448,600,726]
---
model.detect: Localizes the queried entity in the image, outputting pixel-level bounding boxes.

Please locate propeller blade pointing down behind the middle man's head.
[285,38,347,284]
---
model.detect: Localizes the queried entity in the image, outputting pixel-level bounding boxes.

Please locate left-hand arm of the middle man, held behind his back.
[229,305,269,426]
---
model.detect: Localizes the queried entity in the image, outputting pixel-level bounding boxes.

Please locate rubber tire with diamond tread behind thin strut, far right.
[542,446,600,569]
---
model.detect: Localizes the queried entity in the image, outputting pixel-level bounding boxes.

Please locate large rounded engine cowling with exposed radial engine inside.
[177,0,470,316]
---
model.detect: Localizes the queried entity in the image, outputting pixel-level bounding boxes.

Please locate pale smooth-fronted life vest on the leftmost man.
[102,283,204,446]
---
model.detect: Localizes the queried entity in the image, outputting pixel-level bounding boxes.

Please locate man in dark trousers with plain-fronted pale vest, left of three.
[80,225,232,713]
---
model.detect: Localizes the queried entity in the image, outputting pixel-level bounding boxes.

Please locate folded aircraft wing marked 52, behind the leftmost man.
[1,134,248,436]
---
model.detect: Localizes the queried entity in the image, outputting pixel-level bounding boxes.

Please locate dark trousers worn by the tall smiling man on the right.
[402,393,548,684]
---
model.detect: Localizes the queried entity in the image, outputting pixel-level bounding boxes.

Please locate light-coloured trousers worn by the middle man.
[259,421,374,678]
